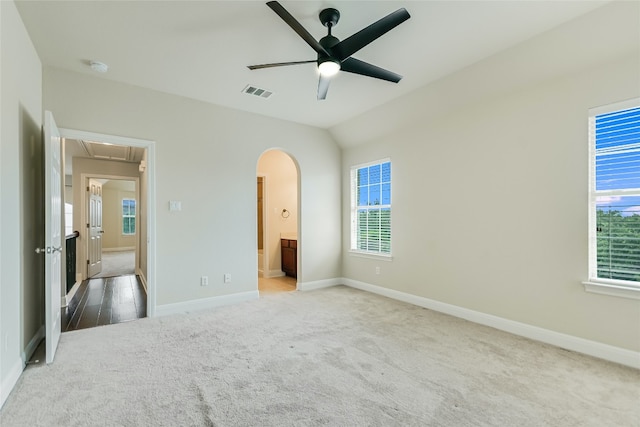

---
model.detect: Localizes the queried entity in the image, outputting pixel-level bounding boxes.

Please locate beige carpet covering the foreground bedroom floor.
[0,286,640,427]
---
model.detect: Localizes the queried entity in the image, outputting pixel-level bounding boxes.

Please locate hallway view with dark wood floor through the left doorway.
[62,162,147,332]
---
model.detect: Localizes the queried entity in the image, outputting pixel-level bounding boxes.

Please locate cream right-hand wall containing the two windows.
[337,3,640,351]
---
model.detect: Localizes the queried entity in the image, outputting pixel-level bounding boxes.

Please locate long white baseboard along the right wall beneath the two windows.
[341,279,640,369]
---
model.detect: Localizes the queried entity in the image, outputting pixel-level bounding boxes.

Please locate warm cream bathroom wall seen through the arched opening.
[258,150,298,274]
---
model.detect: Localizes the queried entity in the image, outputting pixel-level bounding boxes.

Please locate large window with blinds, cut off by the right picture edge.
[589,99,640,290]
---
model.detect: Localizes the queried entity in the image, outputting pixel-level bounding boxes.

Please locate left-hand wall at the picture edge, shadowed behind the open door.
[0,1,43,404]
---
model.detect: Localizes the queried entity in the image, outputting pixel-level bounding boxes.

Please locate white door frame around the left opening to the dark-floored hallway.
[60,128,157,317]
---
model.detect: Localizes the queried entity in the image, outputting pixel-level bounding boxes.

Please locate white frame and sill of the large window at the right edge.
[582,98,640,299]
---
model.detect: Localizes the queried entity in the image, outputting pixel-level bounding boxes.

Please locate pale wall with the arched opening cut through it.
[44,68,341,305]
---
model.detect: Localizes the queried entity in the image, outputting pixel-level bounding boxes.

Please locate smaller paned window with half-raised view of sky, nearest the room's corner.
[351,159,391,256]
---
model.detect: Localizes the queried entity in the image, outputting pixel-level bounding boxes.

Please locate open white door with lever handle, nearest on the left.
[42,111,62,363]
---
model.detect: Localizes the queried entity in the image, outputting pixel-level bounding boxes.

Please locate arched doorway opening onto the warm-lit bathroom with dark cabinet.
[256,149,300,295]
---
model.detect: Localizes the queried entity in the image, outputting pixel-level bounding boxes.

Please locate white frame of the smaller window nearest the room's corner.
[349,157,393,261]
